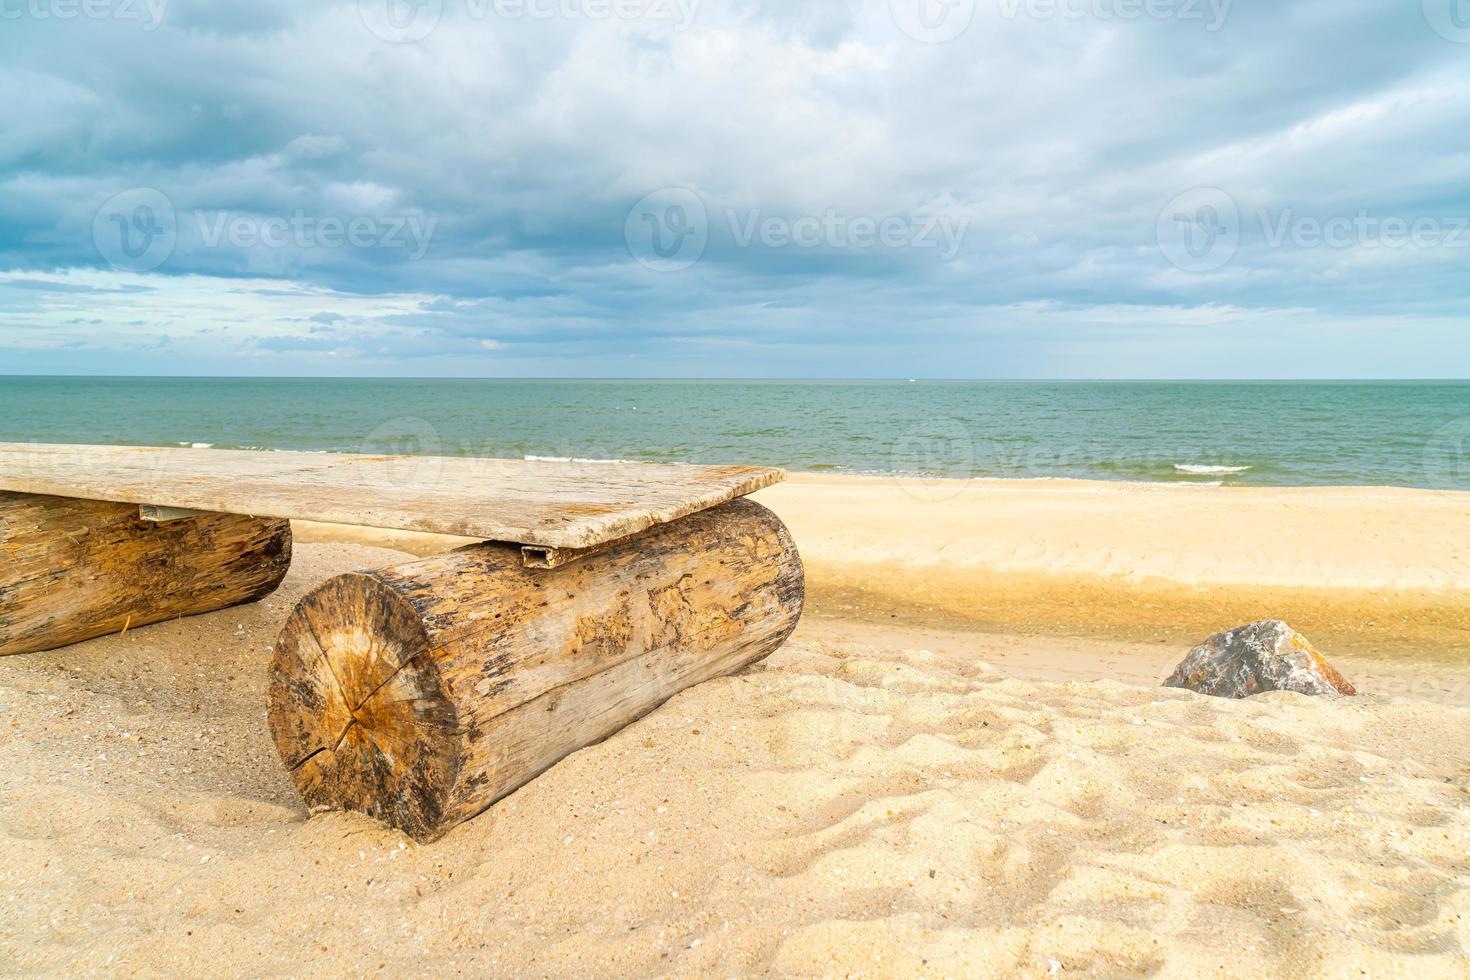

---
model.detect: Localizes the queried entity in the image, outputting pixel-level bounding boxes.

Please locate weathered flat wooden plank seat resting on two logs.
[0,442,785,548]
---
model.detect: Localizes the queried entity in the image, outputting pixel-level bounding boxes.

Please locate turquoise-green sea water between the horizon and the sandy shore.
[0,378,1470,489]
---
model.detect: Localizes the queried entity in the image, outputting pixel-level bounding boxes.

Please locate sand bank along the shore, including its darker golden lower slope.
[760,476,1470,664]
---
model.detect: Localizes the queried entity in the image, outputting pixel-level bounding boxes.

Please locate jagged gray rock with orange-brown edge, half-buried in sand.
[1164,620,1358,698]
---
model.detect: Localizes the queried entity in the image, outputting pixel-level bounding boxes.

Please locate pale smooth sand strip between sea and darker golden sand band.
[757,473,1470,591]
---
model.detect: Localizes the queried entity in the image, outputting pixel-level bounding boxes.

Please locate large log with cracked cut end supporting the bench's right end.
[269,500,804,840]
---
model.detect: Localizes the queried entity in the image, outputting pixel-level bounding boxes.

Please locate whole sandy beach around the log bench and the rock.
[0,478,1470,977]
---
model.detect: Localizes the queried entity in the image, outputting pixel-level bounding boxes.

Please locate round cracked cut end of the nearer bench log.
[269,574,459,837]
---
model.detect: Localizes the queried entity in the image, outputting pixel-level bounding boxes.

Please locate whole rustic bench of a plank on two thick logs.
[0,444,804,840]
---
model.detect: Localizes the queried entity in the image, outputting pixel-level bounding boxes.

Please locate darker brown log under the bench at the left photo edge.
[0,492,291,654]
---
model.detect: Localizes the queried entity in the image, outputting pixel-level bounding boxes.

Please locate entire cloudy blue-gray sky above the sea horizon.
[0,0,1470,378]
